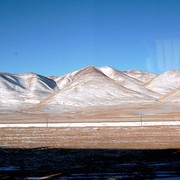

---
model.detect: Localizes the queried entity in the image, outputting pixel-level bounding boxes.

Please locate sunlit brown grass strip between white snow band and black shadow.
[0,126,180,149]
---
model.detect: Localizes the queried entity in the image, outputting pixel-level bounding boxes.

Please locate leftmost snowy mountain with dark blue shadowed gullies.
[0,73,58,103]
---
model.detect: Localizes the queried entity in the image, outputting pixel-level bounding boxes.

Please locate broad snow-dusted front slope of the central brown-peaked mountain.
[47,67,155,105]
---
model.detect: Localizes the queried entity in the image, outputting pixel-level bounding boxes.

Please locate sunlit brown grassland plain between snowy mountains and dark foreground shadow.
[0,104,180,149]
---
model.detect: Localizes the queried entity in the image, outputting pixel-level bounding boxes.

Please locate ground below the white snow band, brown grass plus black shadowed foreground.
[0,126,180,179]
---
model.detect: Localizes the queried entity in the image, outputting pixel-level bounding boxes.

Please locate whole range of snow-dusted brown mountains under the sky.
[0,66,180,106]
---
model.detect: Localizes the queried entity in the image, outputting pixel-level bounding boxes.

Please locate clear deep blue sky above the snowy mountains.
[0,0,180,76]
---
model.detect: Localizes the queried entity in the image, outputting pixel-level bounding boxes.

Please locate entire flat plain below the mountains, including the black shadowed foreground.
[0,104,180,179]
